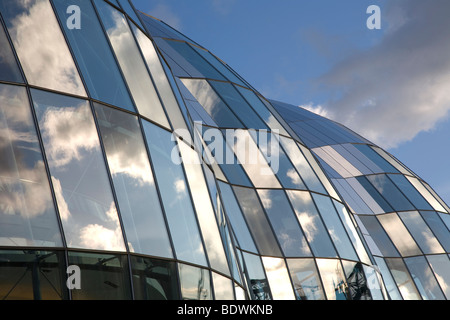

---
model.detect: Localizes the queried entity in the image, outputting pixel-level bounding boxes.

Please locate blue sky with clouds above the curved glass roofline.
[133,0,450,204]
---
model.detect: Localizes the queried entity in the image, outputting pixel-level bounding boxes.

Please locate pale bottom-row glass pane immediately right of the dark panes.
[178,263,212,300]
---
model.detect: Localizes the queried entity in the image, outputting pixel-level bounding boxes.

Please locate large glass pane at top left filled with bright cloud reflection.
[0,0,86,96]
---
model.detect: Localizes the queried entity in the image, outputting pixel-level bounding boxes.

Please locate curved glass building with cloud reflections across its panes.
[0,0,450,300]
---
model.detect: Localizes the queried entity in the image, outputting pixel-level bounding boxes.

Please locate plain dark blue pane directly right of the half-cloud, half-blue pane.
[208,80,269,130]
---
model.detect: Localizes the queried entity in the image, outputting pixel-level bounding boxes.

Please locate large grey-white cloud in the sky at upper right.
[314,0,450,148]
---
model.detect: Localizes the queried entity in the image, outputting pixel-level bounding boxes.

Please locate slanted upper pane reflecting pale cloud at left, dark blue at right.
[182,79,244,128]
